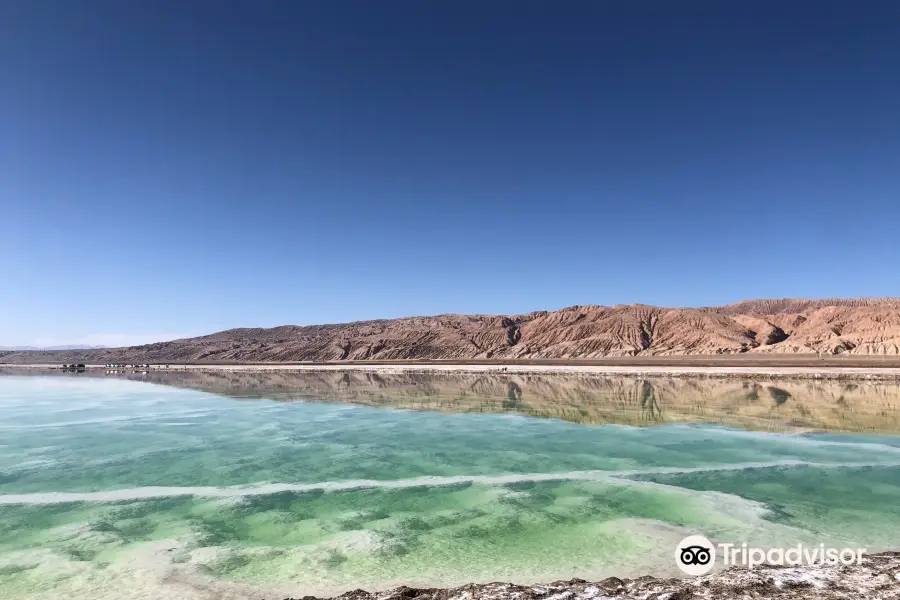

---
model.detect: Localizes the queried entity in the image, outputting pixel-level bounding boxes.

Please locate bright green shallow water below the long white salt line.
[0,480,780,589]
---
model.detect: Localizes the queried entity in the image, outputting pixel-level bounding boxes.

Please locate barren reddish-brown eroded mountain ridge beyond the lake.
[0,298,900,364]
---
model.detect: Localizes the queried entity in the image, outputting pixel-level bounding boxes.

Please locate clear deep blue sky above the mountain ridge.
[0,0,900,345]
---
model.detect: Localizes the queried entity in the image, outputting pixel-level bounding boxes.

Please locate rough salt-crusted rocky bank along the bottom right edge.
[285,552,900,600]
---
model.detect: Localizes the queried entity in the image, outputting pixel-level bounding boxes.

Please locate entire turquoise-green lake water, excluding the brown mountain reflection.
[0,376,900,599]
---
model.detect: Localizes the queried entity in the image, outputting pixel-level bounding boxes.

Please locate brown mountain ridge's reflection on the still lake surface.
[21,370,900,433]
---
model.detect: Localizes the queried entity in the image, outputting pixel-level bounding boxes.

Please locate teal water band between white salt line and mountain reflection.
[0,410,900,494]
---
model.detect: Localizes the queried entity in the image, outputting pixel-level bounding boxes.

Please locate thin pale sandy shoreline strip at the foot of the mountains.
[0,363,900,380]
